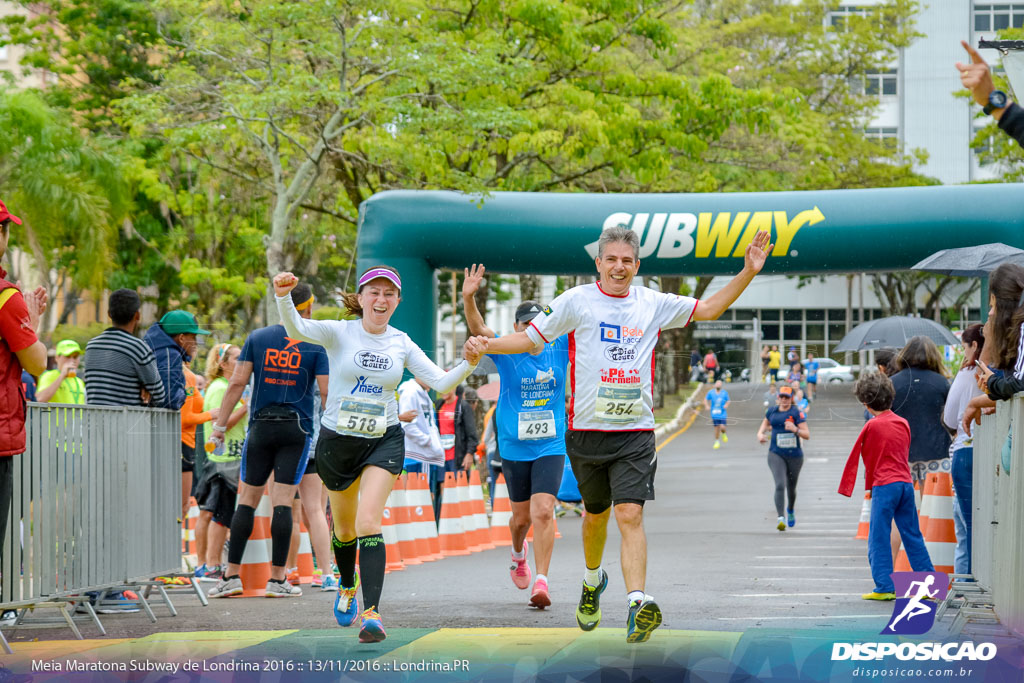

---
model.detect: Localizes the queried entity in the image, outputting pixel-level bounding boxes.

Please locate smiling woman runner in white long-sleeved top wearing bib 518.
[273,266,483,643]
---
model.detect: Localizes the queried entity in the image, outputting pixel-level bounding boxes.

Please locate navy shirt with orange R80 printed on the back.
[239,325,330,434]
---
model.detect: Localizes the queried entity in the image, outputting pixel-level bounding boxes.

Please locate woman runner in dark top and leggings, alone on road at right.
[758,386,811,531]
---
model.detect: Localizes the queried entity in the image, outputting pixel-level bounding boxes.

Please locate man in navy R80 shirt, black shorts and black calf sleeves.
[209,284,329,598]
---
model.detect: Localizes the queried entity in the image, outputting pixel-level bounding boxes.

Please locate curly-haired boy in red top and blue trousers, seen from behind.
[839,373,935,600]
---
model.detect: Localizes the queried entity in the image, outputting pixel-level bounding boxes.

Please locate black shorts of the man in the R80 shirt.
[242,407,312,486]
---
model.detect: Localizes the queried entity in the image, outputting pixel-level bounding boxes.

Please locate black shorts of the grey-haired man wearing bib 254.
[565,430,657,514]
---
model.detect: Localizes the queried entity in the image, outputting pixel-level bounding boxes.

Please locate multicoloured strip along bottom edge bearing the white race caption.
[0,629,1024,683]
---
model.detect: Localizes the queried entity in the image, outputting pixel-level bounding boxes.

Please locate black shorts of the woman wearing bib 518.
[316,425,406,490]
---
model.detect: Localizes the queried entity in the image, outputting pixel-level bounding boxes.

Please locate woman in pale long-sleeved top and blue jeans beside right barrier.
[942,325,985,573]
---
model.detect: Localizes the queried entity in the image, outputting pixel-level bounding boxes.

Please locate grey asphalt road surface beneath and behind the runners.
[7,384,892,641]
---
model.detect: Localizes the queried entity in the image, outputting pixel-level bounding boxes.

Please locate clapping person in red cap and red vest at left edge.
[0,202,47,626]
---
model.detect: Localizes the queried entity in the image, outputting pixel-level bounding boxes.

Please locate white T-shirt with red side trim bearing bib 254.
[526,284,697,431]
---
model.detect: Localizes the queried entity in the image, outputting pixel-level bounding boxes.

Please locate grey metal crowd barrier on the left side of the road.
[0,403,181,643]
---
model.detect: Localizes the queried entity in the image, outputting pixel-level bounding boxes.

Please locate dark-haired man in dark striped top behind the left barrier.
[85,290,167,407]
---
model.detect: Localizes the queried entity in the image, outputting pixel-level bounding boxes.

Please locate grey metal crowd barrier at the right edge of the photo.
[971,393,1024,635]
